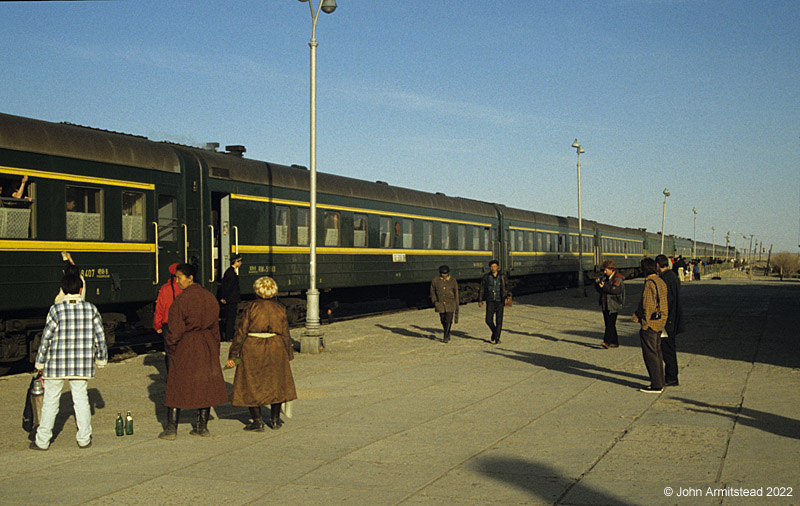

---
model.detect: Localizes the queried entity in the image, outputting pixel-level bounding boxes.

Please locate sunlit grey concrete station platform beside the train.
[0,280,800,506]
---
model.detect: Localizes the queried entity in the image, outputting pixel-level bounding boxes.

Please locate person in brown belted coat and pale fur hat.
[225,276,297,432]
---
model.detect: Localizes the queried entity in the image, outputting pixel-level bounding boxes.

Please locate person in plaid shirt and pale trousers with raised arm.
[30,274,108,450]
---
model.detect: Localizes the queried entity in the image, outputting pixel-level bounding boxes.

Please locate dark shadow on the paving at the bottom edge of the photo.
[473,457,635,506]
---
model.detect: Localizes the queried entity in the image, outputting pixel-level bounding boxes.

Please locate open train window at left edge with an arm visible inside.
[0,175,36,239]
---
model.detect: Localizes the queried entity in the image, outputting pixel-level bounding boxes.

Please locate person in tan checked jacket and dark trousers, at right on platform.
[633,257,669,394]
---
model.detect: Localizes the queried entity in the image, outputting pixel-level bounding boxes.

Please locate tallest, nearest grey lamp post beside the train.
[300,0,336,336]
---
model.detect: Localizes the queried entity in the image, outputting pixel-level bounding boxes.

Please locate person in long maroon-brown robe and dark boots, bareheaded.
[158,264,228,440]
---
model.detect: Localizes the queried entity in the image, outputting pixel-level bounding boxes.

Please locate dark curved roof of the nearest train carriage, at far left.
[0,113,180,173]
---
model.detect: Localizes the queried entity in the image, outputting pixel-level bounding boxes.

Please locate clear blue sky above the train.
[0,0,800,251]
